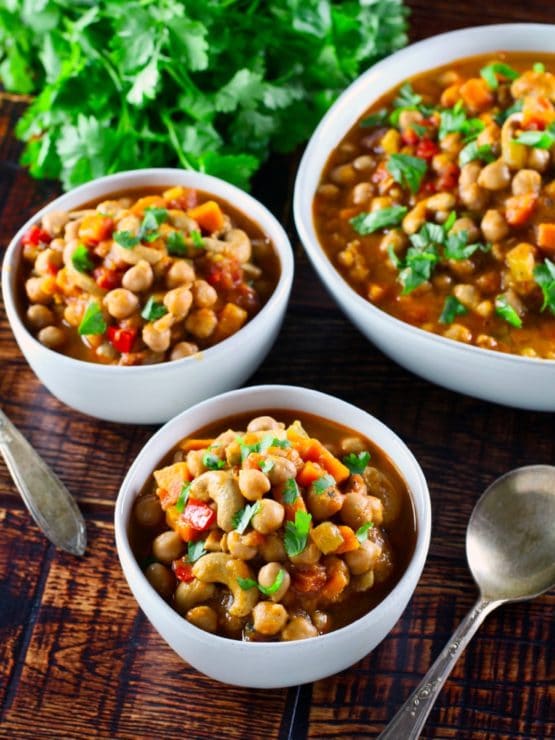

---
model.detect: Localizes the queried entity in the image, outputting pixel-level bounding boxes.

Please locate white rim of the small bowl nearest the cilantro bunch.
[2,167,294,378]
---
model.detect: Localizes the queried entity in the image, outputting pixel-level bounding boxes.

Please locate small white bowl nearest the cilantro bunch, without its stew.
[2,168,293,424]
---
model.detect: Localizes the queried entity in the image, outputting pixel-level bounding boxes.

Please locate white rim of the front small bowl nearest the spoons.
[114,384,432,652]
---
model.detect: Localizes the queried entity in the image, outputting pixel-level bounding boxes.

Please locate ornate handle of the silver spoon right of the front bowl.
[378,597,502,740]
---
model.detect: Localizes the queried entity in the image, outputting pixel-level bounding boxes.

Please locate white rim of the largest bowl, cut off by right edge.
[293,23,555,371]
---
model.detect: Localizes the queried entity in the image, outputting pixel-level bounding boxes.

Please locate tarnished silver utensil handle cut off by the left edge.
[0,410,87,555]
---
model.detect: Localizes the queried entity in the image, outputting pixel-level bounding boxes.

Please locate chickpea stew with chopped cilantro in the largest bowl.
[314,53,555,359]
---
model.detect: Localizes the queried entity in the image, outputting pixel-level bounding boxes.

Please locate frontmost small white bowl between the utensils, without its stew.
[115,385,431,688]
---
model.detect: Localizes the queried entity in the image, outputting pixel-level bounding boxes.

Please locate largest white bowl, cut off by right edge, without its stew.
[294,23,555,411]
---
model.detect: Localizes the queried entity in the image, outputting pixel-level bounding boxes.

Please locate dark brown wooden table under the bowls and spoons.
[0,0,555,740]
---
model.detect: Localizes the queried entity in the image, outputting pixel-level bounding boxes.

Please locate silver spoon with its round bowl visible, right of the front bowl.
[379,465,555,740]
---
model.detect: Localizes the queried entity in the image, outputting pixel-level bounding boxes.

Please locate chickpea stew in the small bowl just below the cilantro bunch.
[22,187,279,365]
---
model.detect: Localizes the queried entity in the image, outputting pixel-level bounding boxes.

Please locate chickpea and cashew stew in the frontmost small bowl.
[129,411,416,641]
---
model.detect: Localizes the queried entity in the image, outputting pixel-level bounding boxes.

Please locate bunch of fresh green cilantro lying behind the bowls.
[0,0,407,189]
